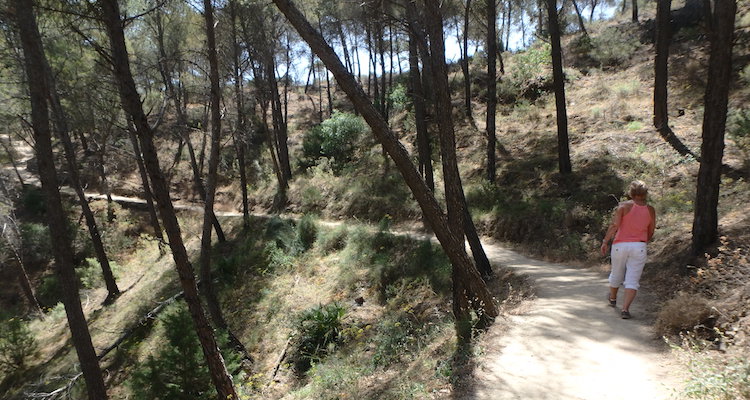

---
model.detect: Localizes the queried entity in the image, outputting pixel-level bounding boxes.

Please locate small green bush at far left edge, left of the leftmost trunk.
[0,318,37,373]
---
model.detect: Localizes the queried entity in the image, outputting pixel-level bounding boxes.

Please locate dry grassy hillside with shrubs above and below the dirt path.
[0,4,750,399]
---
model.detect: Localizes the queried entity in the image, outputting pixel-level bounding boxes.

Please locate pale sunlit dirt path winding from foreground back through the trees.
[5,135,680,400]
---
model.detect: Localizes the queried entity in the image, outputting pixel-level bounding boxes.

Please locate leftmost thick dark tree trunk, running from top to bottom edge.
[14,0,107,400]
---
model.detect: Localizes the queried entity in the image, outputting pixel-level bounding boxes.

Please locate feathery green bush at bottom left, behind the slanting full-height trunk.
[130,303,240,400]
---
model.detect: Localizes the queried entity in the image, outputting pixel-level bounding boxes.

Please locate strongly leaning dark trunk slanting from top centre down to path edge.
[274,0,498,338]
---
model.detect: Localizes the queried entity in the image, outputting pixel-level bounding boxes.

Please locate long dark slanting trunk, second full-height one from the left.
[98,0,238,399]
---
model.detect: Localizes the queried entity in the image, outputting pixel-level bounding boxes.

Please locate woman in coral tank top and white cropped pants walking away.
[601,181,656,319]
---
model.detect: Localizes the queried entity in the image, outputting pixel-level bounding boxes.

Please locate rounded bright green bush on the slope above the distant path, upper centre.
[300,111,366,172]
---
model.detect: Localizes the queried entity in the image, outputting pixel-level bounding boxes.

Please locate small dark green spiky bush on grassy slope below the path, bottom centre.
[291,303,346,373]
